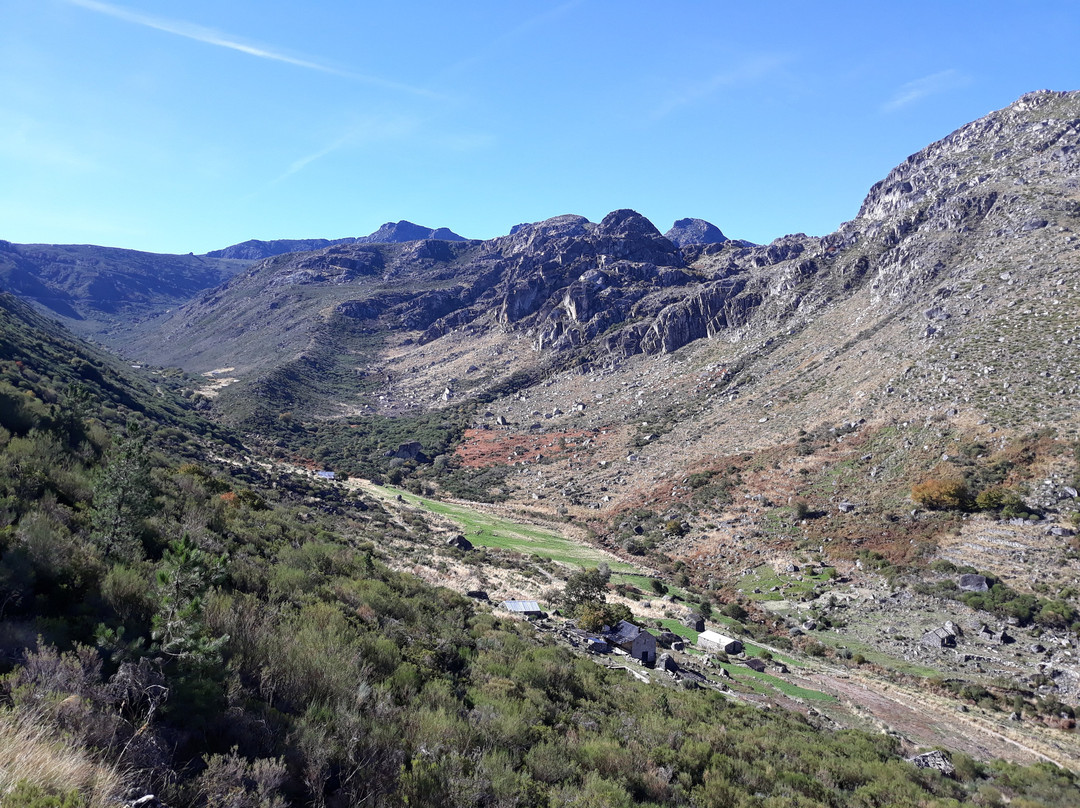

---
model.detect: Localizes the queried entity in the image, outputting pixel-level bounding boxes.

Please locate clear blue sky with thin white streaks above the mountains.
[0,0,1080,253]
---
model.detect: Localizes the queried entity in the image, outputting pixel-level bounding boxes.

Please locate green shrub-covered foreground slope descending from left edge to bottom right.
[6,300,1080,808]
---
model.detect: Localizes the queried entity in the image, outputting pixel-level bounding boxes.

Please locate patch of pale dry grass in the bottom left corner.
[0,711,124,808]
